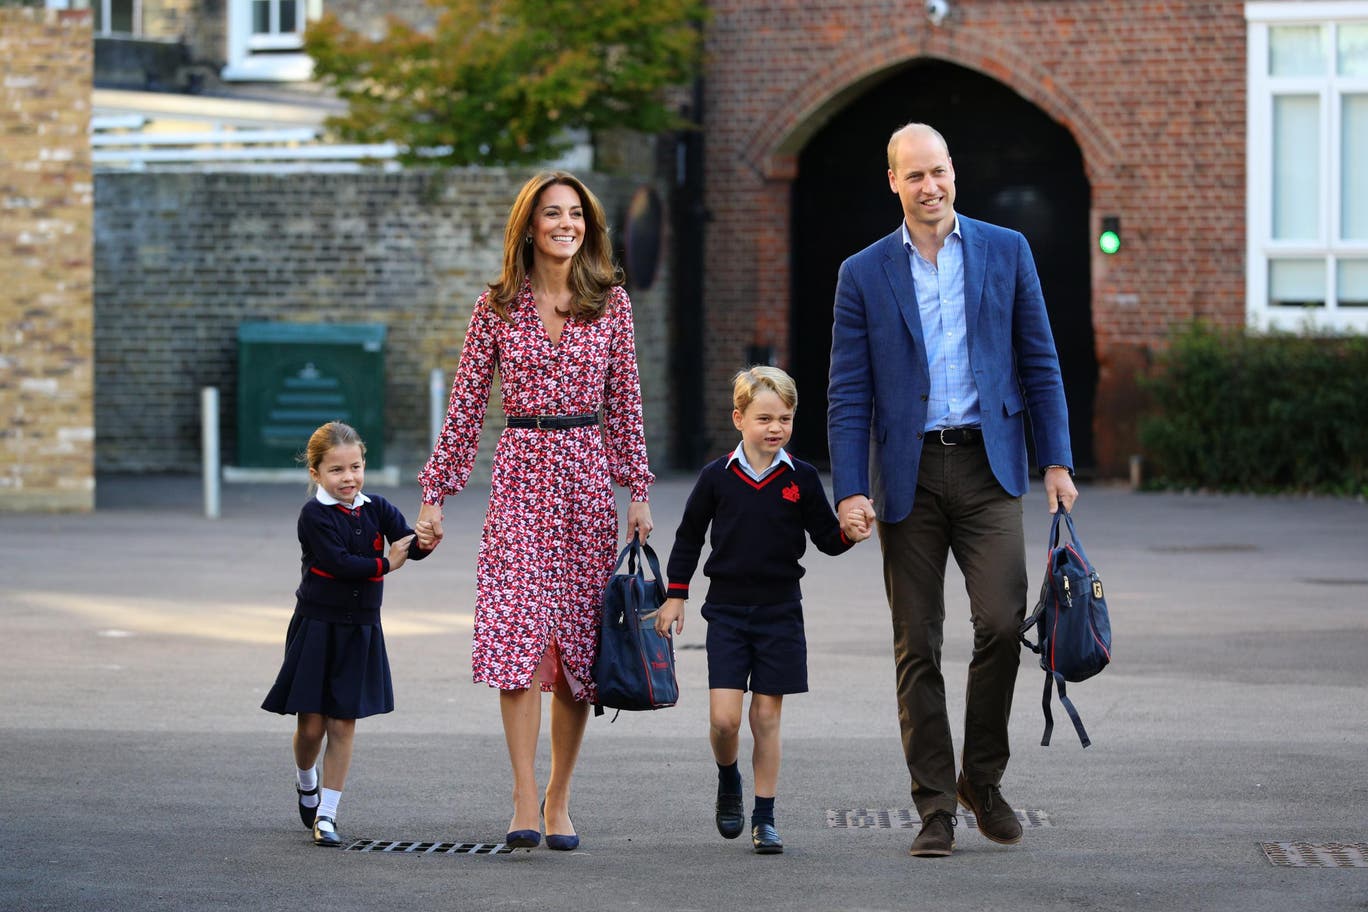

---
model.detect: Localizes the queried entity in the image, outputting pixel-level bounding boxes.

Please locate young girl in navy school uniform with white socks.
[261,421,428,846]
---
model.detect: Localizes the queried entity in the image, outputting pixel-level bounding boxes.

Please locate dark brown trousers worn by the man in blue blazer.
[878,442,1026,819]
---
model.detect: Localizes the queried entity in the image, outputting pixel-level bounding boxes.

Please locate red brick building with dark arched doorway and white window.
[702,0,1368,474]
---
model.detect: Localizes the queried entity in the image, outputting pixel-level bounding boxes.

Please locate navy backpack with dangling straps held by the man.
[1021,506,1111,748]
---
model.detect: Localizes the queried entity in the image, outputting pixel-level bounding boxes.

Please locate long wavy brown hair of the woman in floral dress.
[488,171,622,323]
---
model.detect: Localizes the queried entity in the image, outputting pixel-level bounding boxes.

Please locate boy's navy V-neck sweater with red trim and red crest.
[666,454,854,604]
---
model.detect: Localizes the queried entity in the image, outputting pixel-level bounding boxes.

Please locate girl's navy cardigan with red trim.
[294,495,431,623]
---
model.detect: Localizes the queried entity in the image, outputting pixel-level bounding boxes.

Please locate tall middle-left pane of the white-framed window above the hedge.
[1274,94,1320,241]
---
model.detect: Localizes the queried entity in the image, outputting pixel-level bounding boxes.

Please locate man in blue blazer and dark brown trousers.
[826,123,1078,857]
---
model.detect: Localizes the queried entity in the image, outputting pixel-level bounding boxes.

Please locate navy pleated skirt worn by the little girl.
[261,613,394,719]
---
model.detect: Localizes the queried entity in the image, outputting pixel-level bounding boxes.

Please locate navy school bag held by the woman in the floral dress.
[594,536,680,719]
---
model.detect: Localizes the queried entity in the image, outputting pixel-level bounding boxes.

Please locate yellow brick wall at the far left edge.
[0,7,94,511]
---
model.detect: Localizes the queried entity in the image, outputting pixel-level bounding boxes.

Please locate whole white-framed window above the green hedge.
[1245,0,1368,332]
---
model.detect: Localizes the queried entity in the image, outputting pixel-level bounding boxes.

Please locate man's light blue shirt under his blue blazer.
[903,216,982,431]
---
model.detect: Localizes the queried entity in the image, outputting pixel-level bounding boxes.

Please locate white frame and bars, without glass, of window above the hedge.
[1245,0,1368,334]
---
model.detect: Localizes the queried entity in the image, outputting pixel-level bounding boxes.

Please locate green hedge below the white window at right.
[1140,323,1368,495]
